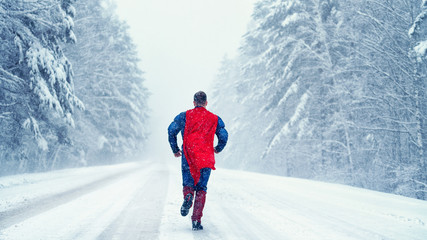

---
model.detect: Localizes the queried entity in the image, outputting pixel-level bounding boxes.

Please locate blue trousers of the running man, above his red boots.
[181,154,211,192]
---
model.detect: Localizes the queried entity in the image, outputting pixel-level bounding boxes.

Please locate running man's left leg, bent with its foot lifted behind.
[181,157,194,217]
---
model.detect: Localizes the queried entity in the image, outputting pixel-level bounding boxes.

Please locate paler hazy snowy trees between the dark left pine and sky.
[62,0,149,164]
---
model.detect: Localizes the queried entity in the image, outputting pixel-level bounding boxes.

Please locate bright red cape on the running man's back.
[183,107,218,184]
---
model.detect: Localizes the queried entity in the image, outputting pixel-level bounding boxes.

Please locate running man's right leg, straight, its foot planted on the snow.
[191,168,211,230]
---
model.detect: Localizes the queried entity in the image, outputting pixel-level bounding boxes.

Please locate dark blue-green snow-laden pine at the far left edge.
[0,0,83,172]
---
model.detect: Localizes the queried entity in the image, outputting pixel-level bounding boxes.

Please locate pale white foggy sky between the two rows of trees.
[116,0,256,156]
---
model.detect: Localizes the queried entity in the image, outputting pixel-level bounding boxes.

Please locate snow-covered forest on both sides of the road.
[0,0,427,200]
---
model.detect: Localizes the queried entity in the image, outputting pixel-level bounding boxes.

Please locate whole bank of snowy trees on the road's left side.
[0,0,149,175]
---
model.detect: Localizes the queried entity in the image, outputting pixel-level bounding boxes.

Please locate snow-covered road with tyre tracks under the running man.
[0,160,427,240]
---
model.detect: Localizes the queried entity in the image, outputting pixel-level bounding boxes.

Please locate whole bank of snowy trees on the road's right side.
[211,0,427,199]
